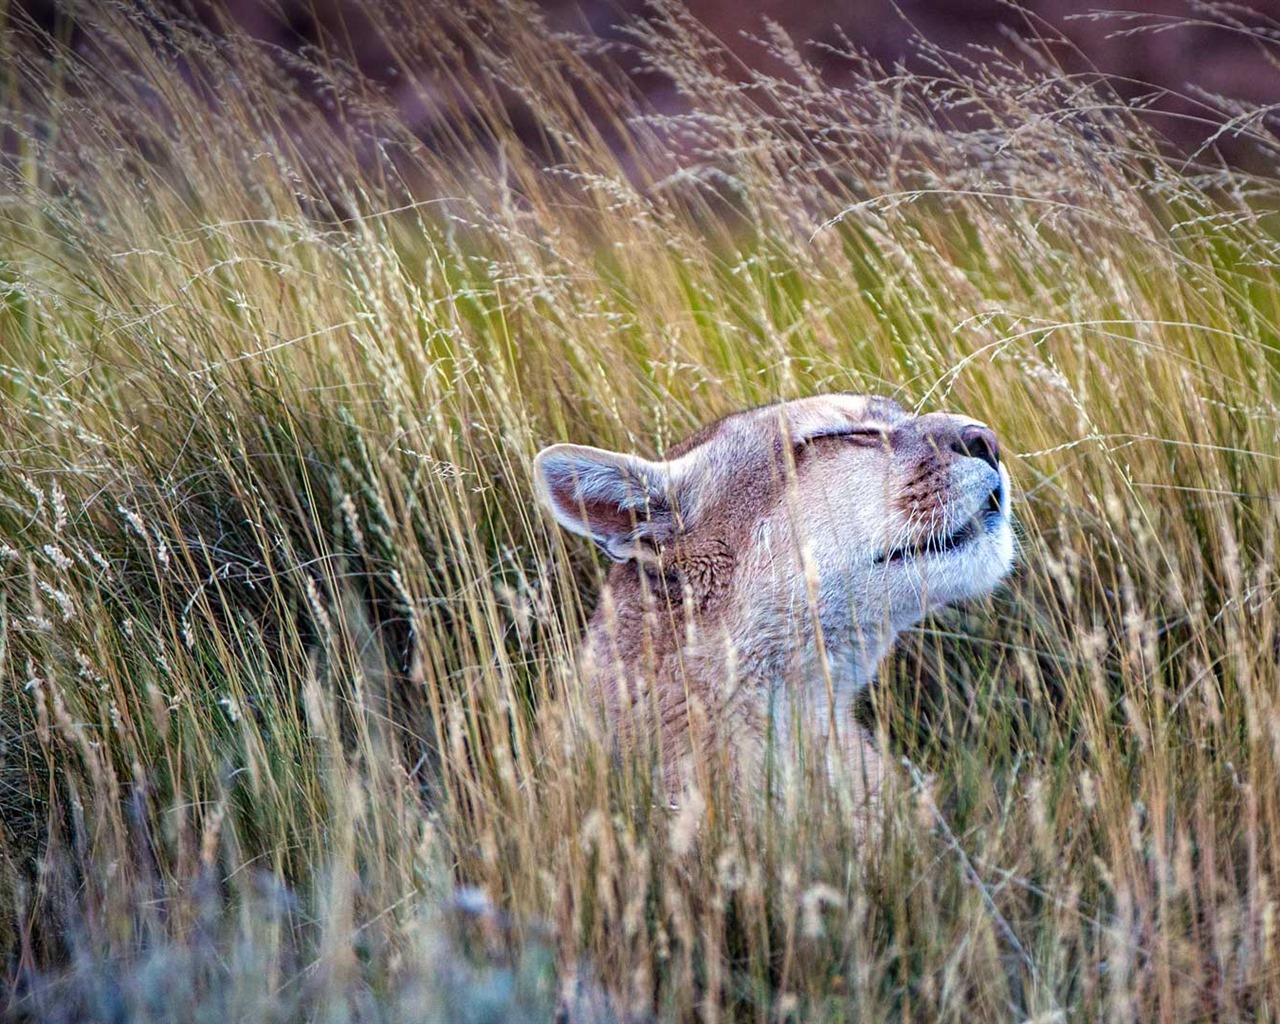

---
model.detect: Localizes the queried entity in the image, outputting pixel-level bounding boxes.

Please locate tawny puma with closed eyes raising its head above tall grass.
[534,394,1014,791]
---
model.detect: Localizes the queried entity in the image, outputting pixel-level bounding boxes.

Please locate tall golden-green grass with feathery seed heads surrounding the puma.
[0,0,1280,1024]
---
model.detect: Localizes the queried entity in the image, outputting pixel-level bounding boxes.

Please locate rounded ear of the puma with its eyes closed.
[534,444,677,562]
